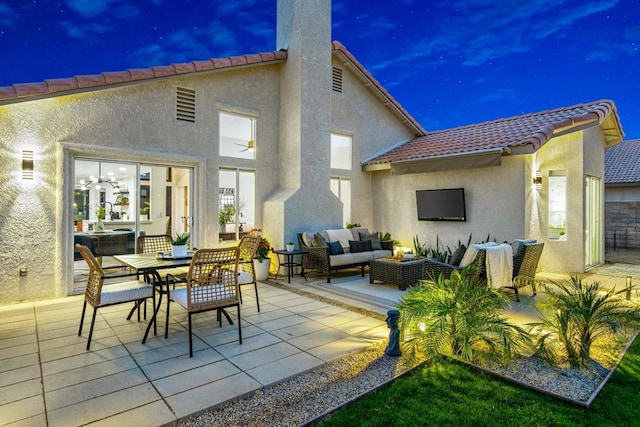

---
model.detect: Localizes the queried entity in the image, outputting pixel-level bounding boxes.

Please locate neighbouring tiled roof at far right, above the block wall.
[604,139,640,184]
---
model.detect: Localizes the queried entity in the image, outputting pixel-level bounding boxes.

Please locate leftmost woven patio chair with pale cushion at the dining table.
[76,244,156,350]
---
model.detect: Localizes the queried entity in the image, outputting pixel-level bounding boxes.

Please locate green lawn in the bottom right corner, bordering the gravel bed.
[320,340,640,427]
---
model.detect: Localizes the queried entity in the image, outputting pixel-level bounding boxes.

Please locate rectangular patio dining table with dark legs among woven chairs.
[113,252,193,344]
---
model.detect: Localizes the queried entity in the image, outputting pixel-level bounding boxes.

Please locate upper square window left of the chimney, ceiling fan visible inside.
[220,112,255,159]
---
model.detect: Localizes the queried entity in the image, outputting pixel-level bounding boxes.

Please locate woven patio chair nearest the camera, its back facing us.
[171,247,242,357]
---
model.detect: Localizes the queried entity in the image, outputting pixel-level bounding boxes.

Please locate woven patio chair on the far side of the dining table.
[136,234,189,338]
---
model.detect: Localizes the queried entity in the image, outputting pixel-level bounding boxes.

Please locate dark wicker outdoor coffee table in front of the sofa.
[369,257,426,291]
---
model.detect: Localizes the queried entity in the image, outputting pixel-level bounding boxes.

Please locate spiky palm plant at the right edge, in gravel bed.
[530,276,640,366]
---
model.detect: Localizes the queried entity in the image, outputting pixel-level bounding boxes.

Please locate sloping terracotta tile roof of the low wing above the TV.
[363,100,622,166]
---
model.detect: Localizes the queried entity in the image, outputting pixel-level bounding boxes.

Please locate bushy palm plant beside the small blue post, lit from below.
[396,267,531,363]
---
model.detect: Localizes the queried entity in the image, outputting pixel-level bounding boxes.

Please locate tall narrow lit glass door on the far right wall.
[584,175,604,268]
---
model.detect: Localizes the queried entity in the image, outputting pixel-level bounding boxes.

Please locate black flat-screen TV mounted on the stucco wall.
[416,188,467,221]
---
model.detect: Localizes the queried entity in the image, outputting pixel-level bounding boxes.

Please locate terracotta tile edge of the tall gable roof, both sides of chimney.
[0,41,426,135]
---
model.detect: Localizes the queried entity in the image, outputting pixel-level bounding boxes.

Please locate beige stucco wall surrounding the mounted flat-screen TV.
[372,155,530,249]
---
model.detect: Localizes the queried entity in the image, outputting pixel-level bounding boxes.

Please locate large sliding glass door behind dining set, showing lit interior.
[72,158,193,292]
